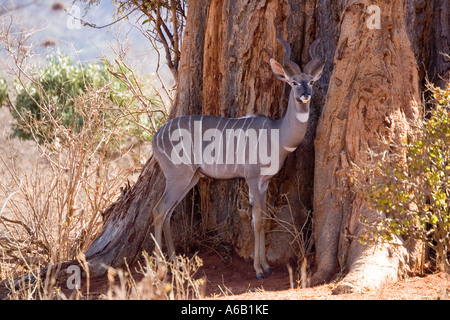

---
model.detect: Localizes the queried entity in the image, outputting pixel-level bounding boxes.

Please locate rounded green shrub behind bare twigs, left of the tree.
[10,53,163,148]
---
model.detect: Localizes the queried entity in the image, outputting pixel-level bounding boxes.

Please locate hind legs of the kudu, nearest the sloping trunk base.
[153,173,200,259]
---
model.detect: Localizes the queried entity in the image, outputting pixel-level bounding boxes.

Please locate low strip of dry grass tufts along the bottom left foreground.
[1,252,205,300]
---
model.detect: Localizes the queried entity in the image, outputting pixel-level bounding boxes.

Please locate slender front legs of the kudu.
[247,179,270,279]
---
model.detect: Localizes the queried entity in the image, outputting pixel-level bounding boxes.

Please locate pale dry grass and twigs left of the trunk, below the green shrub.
[0,79,162,299]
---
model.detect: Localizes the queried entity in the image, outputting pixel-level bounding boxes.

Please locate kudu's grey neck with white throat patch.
[278,90,309,151]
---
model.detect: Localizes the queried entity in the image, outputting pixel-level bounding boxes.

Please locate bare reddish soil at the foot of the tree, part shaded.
[199,253,450,300]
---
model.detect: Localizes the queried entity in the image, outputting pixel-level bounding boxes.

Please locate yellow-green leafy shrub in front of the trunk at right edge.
[356,85,450,272]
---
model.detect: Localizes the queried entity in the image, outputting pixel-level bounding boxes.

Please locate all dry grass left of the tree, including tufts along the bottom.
[0,47,202,299]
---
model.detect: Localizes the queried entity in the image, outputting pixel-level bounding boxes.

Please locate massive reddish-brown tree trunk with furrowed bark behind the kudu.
[2,0,450,298]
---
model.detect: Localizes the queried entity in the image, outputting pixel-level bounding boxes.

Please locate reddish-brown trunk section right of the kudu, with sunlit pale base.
[312,0,420,292]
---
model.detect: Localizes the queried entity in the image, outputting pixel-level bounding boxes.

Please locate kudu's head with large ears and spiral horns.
[270,27,324,112]
